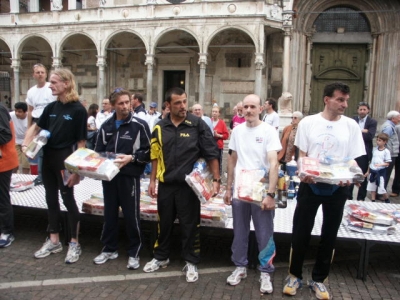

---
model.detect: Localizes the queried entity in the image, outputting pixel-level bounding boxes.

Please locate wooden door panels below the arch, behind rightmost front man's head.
[309,44,367,117]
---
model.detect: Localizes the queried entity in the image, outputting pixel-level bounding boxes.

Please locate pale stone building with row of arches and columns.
[0,0,400,119]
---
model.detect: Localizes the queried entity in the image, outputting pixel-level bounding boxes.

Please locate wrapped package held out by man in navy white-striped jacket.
[64,148,119,181]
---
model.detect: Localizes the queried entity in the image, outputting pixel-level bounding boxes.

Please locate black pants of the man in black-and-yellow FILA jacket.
[154,182,200,264]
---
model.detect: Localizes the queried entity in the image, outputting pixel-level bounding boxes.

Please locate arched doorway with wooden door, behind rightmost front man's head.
[309,7,371,116]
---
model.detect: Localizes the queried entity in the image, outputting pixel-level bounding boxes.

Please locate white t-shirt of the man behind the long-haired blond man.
[26,82,57,118]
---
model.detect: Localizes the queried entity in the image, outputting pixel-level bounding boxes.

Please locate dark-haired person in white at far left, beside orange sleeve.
[10,102,29,174]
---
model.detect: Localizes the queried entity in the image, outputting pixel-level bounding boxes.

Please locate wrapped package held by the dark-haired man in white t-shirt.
[298,157,364,184]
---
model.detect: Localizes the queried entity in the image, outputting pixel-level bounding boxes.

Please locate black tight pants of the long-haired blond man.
[43,147,80,239]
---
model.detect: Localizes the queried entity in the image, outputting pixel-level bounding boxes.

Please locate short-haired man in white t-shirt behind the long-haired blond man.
[26,63,57,185]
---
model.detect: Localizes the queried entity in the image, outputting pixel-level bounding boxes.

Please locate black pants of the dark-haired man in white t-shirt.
[289,183,348,282]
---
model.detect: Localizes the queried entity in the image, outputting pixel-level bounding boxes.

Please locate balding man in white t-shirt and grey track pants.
[224,95,282,294]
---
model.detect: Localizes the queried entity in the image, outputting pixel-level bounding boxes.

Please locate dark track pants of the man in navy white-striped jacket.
[101,173,142,258]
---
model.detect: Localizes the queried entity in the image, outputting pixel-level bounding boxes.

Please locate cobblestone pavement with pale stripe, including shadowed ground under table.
[0,191,400,300]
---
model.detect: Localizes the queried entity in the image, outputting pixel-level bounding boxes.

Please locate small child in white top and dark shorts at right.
[367,133,392,203]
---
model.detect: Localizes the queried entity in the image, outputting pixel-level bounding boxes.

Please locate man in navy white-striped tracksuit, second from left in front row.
[93,88,150,270]
